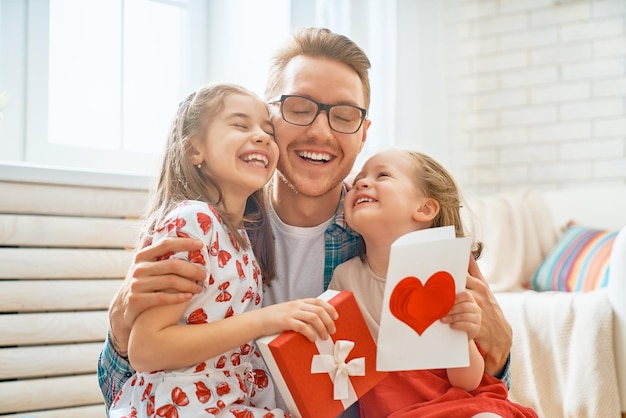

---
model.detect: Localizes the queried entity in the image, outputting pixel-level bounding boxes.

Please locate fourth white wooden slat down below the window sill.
[0,280,122,312]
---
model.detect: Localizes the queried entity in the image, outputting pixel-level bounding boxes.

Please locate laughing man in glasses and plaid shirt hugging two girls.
[98,28,512,414]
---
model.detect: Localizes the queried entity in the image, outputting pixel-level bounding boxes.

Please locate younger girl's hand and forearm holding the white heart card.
[447,291,485,391]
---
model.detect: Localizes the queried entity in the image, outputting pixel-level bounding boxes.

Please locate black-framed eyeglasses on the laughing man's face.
[269,94,367,134]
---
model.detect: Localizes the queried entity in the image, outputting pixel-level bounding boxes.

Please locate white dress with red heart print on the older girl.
[109,201,288,418]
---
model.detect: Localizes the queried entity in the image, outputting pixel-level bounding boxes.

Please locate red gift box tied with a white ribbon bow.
[257,290,387,418]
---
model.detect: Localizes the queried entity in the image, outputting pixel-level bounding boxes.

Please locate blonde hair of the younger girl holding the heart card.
[402,150,483,259]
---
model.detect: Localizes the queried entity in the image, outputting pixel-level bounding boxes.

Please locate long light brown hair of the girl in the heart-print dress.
[139,83,276,283]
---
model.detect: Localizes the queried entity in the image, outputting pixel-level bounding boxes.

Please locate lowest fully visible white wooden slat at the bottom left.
[0,374,104,417]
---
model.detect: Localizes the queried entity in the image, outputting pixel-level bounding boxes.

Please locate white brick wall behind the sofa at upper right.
[443,0,626,193]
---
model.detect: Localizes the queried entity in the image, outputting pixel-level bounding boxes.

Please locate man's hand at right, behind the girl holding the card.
[441,257,513,376]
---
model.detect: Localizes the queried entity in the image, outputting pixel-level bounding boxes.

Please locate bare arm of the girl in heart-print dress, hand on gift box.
[128,298,338,372]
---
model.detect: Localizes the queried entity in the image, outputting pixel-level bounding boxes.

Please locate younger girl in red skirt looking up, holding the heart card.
[329,150,537,418]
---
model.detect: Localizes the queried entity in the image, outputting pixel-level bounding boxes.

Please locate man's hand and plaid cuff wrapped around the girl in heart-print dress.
[98,238,205,408]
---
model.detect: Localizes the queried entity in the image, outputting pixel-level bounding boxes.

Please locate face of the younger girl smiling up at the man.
[344,150,426,245]
